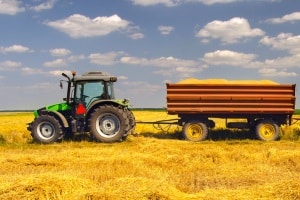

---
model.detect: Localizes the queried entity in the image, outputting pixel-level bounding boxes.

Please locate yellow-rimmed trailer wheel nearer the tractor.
[183,122,208,142]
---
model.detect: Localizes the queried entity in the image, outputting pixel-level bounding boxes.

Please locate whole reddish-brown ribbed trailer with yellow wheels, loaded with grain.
[166,79,296,141]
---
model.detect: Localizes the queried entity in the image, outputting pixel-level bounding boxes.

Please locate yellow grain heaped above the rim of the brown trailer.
[177,78,278,85]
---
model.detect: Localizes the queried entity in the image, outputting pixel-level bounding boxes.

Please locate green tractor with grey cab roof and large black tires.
[27,72,135,144]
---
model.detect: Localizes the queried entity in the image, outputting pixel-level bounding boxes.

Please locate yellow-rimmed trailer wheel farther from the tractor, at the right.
[256,120,280,141]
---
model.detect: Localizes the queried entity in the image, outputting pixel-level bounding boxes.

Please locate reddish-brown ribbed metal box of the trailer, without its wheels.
[166,81,296,117]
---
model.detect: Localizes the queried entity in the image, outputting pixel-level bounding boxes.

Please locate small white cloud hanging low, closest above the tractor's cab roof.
[88,52,124,65]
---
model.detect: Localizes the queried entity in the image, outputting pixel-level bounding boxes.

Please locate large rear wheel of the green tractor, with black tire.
[89,105,129,143]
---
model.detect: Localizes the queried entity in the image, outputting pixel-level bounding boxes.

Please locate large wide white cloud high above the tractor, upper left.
[46,14,130,38]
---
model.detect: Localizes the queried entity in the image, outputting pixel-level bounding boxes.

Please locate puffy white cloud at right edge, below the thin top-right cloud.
[260,33,300,54]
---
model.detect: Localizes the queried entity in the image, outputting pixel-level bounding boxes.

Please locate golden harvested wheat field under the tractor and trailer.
[0,111,300,200]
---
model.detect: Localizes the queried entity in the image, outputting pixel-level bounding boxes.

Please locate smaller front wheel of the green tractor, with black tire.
[31,115,63,144]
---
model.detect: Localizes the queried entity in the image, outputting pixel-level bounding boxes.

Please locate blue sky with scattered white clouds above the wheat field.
[0,0,300,110]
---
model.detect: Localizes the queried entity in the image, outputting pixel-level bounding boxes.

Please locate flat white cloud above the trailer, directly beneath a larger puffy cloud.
[203,50,256,67]
